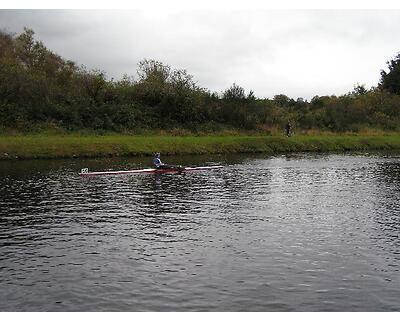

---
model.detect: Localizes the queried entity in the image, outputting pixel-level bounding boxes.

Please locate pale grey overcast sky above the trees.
[0,8,400,99]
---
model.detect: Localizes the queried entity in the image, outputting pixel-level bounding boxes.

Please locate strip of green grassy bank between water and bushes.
[0,134,400,159]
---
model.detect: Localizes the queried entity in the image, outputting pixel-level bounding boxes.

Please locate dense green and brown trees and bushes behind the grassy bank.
[0,29,400,133]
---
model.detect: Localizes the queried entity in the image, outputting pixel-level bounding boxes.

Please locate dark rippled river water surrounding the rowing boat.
[0,155,400,311]
